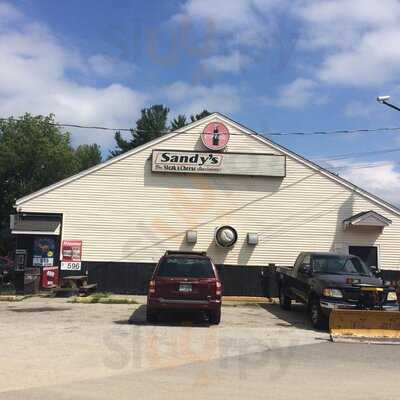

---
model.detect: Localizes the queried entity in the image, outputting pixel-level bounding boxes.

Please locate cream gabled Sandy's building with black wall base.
[12,113,400,294]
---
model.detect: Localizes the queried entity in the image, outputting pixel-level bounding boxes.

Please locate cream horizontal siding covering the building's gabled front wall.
[17,117,400,269]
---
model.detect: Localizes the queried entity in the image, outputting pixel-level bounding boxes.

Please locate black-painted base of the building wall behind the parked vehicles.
[82,261,400,297]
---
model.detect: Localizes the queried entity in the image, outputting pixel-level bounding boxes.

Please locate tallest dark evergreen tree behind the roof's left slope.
[111,104,169,156]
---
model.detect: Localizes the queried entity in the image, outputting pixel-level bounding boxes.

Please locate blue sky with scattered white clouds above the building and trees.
[0,0,400,204]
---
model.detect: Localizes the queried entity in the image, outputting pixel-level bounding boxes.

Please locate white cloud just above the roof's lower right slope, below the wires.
[336,161,400,205]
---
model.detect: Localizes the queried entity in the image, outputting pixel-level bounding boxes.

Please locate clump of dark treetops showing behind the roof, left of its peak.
[110,104,211,157]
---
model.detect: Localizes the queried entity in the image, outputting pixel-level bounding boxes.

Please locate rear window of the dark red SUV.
[157,257,215,278]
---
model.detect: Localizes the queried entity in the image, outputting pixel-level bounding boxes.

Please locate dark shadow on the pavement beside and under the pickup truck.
[260,304,316,331]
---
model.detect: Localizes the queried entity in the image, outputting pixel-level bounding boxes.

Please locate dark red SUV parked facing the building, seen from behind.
[147,251,222,324]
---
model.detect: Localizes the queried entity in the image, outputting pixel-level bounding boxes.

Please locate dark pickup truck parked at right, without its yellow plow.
[276,252,399,329]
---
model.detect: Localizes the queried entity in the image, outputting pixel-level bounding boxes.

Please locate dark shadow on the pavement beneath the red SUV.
[114,305,210,328]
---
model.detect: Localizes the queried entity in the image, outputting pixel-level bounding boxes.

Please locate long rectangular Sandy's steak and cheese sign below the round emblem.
[152,150,286,177]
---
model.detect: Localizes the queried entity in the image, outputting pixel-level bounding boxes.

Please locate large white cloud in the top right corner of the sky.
[293,0,400,87]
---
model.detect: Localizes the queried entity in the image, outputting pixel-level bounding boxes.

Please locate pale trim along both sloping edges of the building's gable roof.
[15,112,400,215]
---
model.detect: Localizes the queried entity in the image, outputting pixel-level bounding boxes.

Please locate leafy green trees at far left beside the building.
[0,114,101,254]
